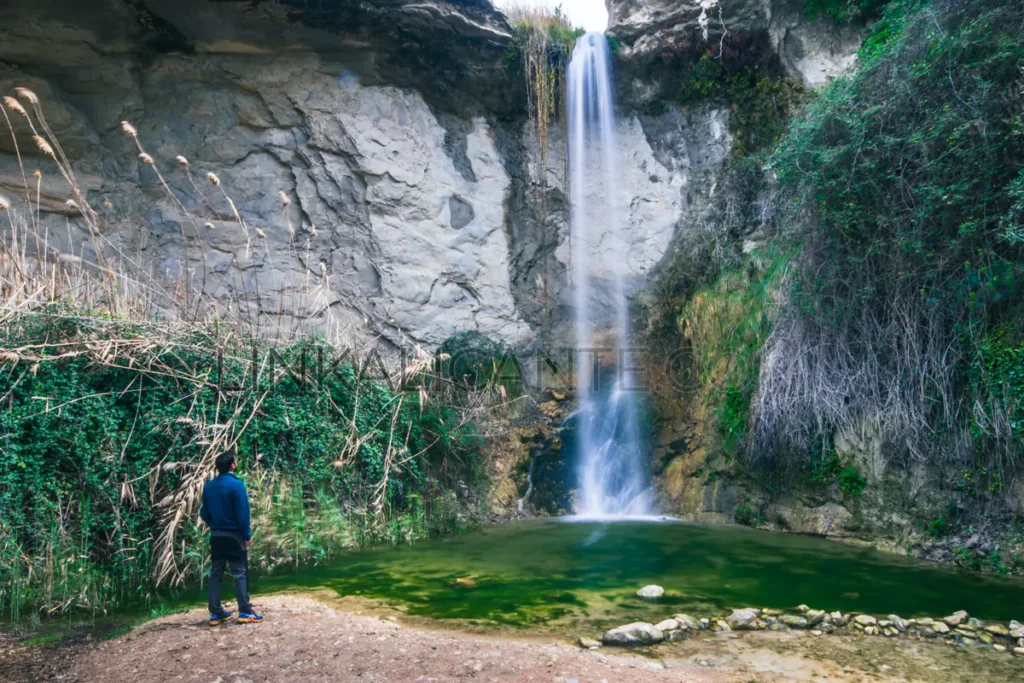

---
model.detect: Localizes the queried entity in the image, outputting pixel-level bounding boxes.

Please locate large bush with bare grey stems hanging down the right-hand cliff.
[754,0,1024,471]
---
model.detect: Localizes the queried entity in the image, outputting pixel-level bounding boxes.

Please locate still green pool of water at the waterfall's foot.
[237,519,1024,630]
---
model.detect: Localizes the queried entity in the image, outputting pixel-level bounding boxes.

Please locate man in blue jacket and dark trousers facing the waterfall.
[199,453,263,626]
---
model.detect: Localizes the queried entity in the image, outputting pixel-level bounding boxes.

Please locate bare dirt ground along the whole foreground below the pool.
[6,596,1024,683]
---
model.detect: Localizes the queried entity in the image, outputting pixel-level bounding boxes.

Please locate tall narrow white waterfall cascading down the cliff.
[567,32,650,517]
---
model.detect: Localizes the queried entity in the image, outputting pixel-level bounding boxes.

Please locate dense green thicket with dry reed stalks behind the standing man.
[0,312,481,616]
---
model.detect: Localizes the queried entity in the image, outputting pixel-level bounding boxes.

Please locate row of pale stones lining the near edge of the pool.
[593,598,1024,656]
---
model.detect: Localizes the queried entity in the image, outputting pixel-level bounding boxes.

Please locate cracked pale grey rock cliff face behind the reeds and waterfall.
[0,0,728,348]
